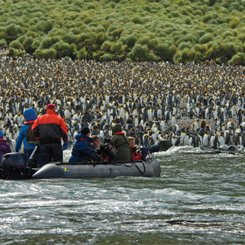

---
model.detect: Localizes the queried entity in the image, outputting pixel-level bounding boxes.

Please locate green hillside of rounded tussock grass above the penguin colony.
[0,0,245,65]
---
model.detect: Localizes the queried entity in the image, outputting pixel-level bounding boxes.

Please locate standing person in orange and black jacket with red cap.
[32,104,68,166]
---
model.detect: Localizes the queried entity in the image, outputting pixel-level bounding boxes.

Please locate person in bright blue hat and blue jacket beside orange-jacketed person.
[15,108,38,161]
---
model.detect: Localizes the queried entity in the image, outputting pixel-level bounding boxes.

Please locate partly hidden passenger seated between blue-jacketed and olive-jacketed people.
[91,135,115,162]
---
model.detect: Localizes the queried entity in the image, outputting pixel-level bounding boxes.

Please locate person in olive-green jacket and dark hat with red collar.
[111,124,131,162]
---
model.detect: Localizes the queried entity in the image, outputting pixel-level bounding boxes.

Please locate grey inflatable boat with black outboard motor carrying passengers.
[0,153,161,179]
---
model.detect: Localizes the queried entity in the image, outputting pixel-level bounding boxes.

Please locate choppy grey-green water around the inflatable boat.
[0,147,245,244]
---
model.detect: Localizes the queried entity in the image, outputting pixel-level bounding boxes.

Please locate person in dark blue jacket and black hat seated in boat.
[69,128,101,163]
